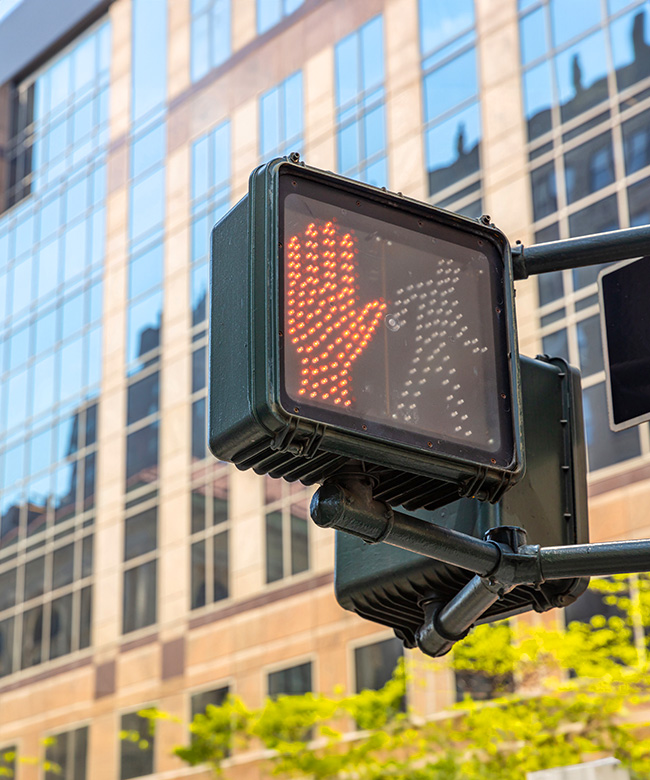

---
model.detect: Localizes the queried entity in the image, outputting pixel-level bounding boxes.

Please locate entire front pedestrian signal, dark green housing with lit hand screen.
[209,158,524,509]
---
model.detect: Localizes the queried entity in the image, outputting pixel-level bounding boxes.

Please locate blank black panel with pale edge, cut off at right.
[598,257,650,431]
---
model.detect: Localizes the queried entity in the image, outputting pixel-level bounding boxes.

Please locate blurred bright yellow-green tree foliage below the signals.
[168,577,650,780]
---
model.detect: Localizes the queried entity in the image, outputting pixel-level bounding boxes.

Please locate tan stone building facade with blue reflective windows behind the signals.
[0,0,650,780]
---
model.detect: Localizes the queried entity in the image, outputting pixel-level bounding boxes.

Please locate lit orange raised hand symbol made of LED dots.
[287,216,386,406]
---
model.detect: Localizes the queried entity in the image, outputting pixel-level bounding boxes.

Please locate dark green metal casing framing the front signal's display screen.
[208,159,524,509]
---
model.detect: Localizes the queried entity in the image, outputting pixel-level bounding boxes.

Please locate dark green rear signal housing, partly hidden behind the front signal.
[334,358,588,646]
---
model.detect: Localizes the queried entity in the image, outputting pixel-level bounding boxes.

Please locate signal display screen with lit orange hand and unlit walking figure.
[280,176,514,466]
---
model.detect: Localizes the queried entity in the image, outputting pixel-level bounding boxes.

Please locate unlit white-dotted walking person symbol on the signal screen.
[386,258,488,437]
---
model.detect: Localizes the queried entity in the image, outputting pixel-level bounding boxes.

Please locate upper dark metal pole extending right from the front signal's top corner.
[512,225,650,279]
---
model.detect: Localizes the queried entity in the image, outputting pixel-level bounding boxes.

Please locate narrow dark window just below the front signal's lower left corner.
[191,463,230,609]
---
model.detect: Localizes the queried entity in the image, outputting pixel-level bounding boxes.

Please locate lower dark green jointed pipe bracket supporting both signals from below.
[310,479,650,656]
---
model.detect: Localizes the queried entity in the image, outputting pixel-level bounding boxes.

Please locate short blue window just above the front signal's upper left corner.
[260,71,303,160]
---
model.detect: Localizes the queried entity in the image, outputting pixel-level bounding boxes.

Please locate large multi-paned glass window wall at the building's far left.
[0,21,104,676]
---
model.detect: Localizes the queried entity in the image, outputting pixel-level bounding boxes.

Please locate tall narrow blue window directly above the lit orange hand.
[334,16,388,187]
